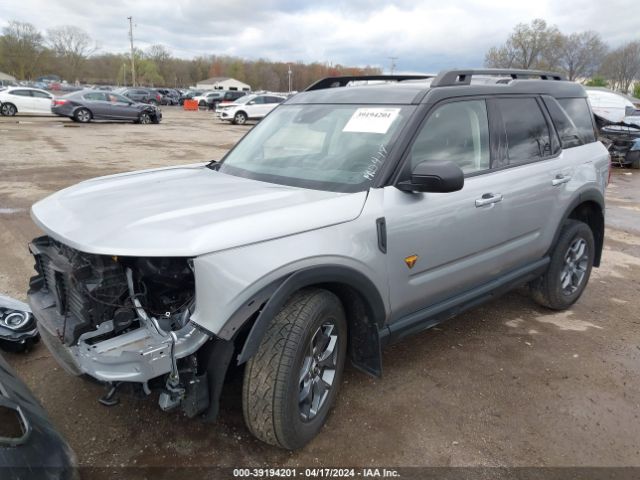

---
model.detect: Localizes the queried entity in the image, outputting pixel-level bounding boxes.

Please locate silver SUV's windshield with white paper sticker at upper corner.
[219,105,415,192]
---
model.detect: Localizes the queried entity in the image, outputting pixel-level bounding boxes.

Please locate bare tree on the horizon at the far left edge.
[0,21,44,79]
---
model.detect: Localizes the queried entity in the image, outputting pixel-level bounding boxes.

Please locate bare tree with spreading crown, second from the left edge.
[47,25,98,80]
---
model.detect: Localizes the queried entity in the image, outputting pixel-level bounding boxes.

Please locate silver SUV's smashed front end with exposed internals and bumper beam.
[29,236,211,416]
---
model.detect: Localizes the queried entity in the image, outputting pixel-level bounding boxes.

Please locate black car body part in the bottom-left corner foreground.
[0,350,78,480]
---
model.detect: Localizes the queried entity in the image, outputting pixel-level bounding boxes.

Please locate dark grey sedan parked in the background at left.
[51,90,162,124]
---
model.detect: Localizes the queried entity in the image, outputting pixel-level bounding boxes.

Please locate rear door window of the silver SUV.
[496,98,553,165]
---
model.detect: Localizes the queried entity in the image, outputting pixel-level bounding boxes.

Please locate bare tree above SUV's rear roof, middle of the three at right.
[557,31,607,80]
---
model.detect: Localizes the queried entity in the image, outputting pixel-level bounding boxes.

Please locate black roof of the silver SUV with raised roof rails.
[286,69,587,105]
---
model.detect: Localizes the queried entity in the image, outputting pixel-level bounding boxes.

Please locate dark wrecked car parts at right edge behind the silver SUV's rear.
[595,115,640,168]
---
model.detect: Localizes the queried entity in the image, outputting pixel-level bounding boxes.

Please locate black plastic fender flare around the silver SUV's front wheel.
[238,265,386,375]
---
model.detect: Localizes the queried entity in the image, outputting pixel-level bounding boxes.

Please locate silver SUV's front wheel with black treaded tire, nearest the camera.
[242,288,347,450]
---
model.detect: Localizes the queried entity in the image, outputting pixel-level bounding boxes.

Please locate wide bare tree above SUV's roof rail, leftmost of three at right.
[485,18,561,68]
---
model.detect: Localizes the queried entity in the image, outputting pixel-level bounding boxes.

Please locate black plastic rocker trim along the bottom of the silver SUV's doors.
[380,257,550,346]
